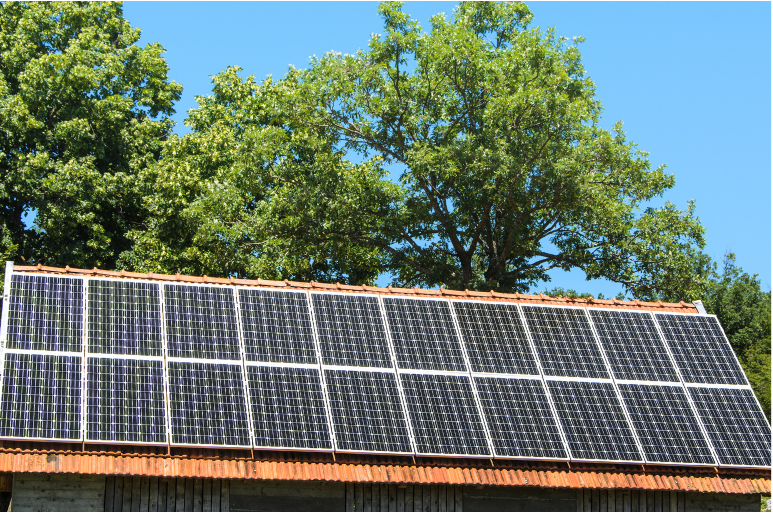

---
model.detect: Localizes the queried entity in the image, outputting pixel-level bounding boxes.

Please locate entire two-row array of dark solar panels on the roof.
[0,273,771,467]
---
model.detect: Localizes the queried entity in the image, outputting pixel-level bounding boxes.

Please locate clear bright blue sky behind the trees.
[124,2,771,298]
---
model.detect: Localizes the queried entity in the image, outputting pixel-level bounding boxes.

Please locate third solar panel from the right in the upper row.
[521,304,610,378]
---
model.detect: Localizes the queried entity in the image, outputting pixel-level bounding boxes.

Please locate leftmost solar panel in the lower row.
[0,352,83,441]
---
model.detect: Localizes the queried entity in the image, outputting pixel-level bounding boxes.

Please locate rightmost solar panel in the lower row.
[687,387,771,467]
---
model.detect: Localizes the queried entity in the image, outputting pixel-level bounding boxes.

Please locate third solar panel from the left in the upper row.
[164,283,242,360]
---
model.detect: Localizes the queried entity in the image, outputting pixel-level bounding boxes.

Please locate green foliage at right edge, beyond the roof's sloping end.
[703,253,771,420]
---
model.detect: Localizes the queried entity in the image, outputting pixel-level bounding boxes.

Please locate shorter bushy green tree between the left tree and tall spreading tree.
[121,68,400,284]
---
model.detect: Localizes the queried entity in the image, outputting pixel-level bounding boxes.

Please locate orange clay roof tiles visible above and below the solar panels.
[0,265,771,494]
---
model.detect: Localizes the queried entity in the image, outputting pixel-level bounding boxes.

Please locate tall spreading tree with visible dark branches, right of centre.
[270,2,703,300]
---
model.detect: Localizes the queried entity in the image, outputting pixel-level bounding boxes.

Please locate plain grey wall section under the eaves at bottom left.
[11,473,105,512]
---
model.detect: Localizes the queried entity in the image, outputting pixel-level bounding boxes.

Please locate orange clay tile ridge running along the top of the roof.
[13,264,697,313]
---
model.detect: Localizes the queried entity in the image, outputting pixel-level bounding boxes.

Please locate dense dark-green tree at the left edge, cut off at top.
[0,2,182,268]
